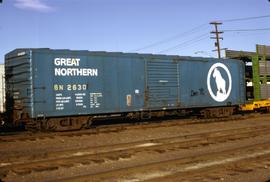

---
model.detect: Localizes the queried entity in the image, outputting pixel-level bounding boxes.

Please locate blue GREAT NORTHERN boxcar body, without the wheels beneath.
[5,49,245,129]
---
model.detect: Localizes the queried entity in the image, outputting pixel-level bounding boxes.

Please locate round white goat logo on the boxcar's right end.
[207,63,232,102]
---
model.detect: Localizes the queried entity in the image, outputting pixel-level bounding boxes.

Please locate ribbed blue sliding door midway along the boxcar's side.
[146,61,179,108]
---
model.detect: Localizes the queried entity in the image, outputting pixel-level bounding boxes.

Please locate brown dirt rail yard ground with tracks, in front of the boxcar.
[0,114,270,181]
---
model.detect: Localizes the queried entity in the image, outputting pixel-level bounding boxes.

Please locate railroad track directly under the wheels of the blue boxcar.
[0,114,260,143]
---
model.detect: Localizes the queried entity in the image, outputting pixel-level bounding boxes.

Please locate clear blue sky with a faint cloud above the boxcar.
[0,0,270,63]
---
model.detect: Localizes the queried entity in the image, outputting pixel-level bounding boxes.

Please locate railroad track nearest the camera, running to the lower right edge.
[58,142,270,182]
